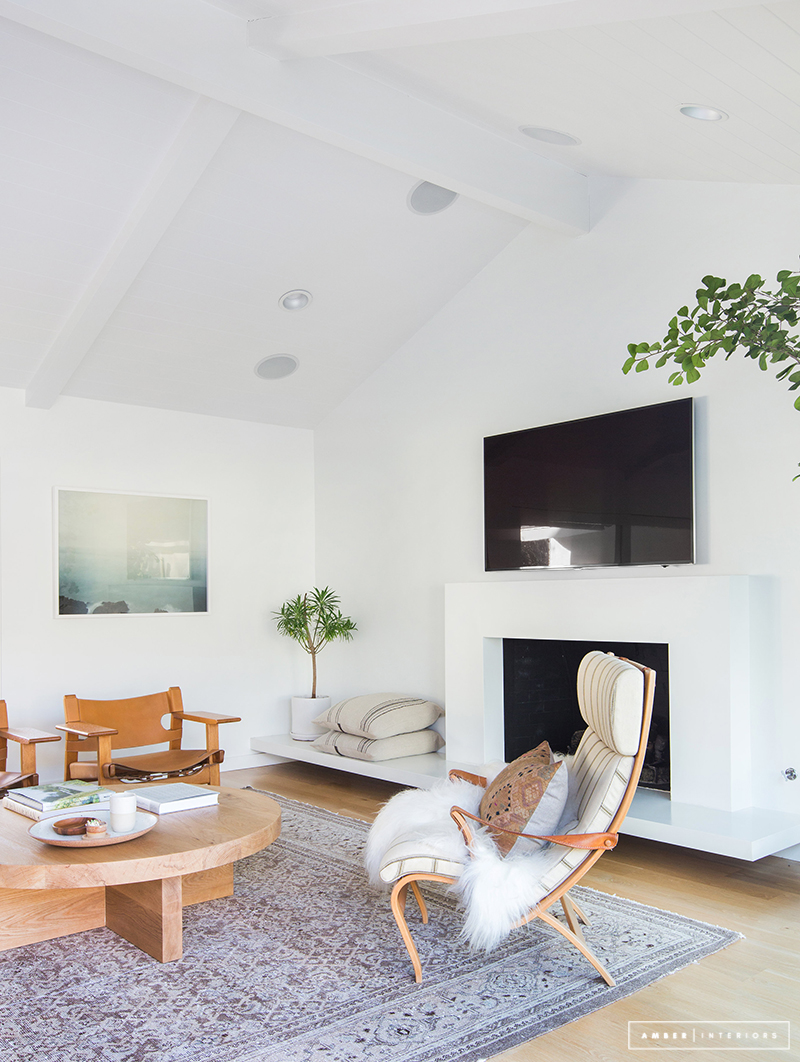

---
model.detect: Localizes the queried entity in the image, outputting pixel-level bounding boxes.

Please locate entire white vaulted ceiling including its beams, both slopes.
[0,0,800,427]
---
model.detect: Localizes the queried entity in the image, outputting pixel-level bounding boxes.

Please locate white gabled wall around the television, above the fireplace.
[316,179,800,812]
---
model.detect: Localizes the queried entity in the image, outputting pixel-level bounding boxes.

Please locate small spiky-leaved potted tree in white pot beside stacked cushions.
[273,586,357,741]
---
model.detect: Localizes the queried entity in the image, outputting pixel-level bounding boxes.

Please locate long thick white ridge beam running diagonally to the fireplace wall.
[0,0,589,235]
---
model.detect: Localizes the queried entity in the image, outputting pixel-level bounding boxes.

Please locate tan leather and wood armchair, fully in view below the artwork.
[56,686,241,786]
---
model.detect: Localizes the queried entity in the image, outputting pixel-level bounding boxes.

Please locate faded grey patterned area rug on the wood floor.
[0,798,738,1062]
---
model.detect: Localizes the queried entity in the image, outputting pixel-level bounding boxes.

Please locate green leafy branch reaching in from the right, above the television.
[623,270,800,479]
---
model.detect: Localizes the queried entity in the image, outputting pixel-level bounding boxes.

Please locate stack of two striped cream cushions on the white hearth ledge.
[312,693,444,760]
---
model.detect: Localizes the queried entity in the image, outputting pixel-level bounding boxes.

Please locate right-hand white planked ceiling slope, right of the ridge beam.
[350,3,800,184]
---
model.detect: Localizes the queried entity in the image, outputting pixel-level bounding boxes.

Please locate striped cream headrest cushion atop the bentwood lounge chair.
[578,651,645,756]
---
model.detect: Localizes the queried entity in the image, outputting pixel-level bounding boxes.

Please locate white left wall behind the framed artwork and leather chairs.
[0,389,314,781]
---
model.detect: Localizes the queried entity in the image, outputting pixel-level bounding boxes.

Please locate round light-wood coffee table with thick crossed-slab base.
[0,786,280,962]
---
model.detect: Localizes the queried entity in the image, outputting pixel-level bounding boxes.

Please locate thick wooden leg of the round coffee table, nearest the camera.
[105,877,183,962]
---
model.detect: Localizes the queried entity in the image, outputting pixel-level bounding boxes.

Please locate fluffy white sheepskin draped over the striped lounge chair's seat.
[364,760,577,952]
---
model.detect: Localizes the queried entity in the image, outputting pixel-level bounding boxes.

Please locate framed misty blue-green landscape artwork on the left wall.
[55,490,208,616]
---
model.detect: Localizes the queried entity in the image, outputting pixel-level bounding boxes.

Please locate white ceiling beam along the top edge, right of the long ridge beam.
[249,0,760,59]
